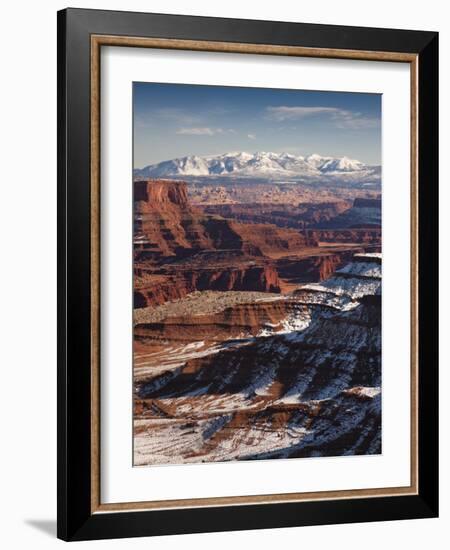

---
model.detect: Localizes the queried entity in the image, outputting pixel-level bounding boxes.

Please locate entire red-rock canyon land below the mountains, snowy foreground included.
[133,178,381,466]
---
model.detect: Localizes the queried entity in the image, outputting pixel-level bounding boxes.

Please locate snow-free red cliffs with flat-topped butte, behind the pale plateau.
[134,180,381,308]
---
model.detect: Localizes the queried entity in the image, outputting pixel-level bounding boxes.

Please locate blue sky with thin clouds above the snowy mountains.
[133,82,381,168]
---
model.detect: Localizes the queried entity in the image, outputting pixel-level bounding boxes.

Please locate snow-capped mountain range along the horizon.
[134,152,381,183]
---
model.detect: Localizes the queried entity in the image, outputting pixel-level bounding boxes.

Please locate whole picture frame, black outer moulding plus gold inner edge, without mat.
[58,9,438,540]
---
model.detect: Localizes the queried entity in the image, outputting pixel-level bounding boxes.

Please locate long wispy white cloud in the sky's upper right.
[266,105,379,130]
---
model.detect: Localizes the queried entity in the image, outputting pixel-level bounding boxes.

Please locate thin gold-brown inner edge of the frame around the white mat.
[90,34,419,514]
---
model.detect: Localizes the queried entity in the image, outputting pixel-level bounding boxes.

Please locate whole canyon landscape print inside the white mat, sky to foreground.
[129,82,382,466]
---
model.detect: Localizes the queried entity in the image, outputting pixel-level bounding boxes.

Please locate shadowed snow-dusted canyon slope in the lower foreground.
[134,254,381,465]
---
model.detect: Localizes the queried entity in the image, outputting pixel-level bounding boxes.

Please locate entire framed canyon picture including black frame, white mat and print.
[58,9,438,540]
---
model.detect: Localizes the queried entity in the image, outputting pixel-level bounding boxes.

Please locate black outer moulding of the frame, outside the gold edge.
[57,8,438,541]
